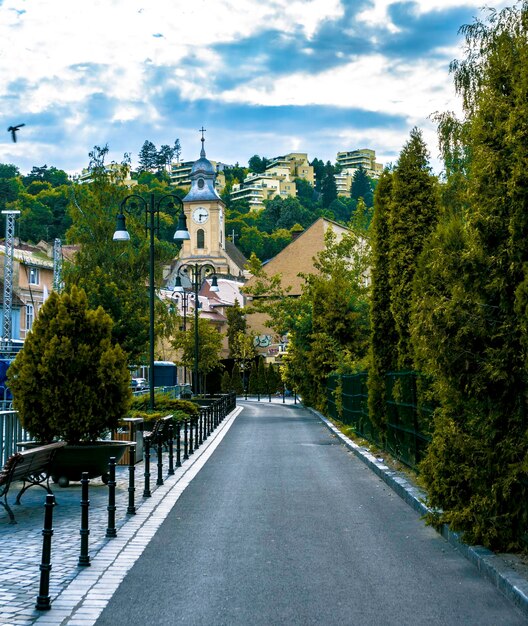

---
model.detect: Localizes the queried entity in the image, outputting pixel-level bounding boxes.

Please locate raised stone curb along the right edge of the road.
[304,407,528,617]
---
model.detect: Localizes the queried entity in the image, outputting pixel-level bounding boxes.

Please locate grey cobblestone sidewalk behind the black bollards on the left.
[0,434,209,626]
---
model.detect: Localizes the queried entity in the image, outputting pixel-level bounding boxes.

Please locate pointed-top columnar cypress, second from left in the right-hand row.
[389,128,438,370]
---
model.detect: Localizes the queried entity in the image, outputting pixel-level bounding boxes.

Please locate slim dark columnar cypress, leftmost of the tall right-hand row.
[368,170,397,436]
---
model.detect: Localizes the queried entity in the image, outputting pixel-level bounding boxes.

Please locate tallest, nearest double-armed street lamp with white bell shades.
[113,193,190,410]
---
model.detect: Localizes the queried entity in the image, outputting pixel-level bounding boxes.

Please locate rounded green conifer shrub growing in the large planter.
[8,287,130,443]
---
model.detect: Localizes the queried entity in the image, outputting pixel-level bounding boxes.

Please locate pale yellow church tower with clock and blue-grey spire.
[179,128,232,274]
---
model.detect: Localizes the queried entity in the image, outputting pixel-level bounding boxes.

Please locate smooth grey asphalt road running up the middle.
[96,402,526,626]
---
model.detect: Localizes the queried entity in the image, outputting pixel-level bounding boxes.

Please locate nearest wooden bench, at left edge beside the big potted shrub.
[0,441,66,524]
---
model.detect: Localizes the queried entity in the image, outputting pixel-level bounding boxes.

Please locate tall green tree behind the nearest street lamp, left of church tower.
[64,146,174,363]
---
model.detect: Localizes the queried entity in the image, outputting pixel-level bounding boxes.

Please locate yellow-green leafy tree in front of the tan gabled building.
[248,224,369,409]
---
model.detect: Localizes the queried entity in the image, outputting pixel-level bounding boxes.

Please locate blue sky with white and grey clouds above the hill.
[0,0,513,173]
